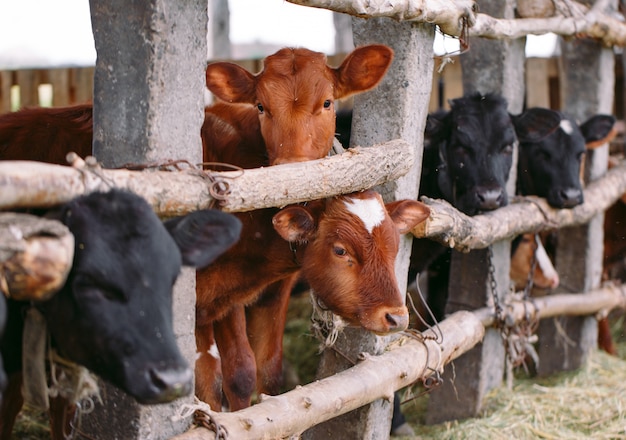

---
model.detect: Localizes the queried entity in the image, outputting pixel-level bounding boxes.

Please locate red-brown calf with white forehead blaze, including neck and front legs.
[196,191,429,410]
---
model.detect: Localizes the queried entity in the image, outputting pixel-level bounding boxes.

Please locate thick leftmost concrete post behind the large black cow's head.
[82,0,207,440]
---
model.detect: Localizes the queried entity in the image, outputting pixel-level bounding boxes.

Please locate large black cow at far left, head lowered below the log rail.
[0,190,241,438]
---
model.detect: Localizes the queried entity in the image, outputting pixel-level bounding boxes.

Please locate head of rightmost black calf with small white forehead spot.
[513,108,615,209]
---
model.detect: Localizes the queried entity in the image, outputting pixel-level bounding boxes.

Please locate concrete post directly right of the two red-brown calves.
[303,18,434,439]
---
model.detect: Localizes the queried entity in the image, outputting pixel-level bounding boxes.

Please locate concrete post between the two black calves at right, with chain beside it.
[426,0,526,424]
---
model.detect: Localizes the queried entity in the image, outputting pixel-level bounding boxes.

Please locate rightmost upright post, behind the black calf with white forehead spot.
[537,25,615,376]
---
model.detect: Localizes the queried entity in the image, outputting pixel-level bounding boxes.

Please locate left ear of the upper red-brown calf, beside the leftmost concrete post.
[206,62,256,104]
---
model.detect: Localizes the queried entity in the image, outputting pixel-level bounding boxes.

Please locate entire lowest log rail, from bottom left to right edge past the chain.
[168,286,626,440]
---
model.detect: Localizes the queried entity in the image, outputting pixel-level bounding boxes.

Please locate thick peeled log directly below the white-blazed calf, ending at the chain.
[174,311,484,440]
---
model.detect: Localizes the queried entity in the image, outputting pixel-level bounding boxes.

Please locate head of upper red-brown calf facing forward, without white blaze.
[206,45,393,165]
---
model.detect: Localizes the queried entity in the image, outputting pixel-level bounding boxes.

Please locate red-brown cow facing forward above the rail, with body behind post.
[0,45,400,412]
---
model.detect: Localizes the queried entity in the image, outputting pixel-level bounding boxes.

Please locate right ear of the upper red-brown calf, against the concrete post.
[334,44,393,99]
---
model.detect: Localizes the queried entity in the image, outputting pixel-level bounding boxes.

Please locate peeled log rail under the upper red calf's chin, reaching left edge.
[0,139,415,217]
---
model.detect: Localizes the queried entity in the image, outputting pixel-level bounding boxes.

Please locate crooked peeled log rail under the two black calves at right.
[413,162,626,252]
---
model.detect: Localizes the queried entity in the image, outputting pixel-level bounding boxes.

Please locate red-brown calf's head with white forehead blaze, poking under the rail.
[273,191,430,334]
